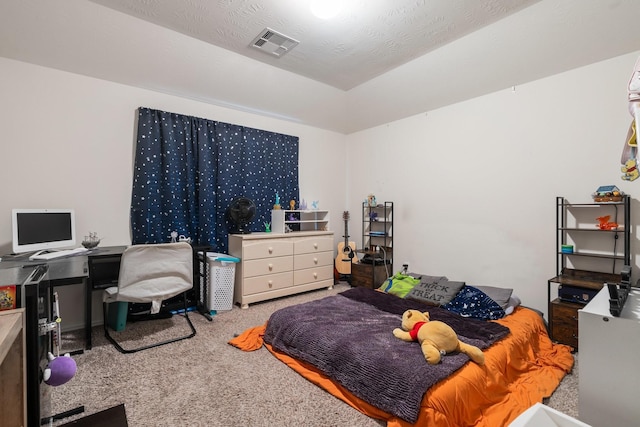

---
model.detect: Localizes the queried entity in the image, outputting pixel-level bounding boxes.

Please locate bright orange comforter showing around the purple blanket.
[229,307,573,427]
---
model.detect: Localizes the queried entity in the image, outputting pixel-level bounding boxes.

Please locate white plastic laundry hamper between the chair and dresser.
[200,252,240,314]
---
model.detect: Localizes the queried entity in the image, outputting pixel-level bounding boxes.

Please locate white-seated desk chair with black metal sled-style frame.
[103,242,196,353]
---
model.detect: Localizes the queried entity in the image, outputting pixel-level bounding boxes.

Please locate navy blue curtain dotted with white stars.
[131,107,300,253]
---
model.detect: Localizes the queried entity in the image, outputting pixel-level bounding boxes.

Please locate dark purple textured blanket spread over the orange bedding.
[264,288,509,423]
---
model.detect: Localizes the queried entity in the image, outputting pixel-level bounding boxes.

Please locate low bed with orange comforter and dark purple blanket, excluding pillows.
[230,280,574,427]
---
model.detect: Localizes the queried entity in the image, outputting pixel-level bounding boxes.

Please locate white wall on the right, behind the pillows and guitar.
[348,54,640,313]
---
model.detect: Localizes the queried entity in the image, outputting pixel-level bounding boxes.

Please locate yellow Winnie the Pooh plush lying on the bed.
[393,310,484,365]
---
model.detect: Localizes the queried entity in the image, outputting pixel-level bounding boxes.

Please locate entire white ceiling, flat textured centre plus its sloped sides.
[0,0,640,134]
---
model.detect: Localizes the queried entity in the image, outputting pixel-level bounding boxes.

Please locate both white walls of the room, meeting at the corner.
[0,50,640,325]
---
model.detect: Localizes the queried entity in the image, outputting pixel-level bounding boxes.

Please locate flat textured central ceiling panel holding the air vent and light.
[92,0,539,90]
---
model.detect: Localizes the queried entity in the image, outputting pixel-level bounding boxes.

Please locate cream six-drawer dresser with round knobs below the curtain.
[229,231,334,308]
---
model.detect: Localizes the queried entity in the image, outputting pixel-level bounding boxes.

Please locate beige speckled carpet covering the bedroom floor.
[52,284,577,427]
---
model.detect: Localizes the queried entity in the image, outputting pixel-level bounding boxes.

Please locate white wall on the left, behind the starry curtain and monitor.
[0,58,347,325]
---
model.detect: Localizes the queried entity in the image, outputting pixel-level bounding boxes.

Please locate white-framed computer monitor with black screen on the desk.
[11,209,76,253]
